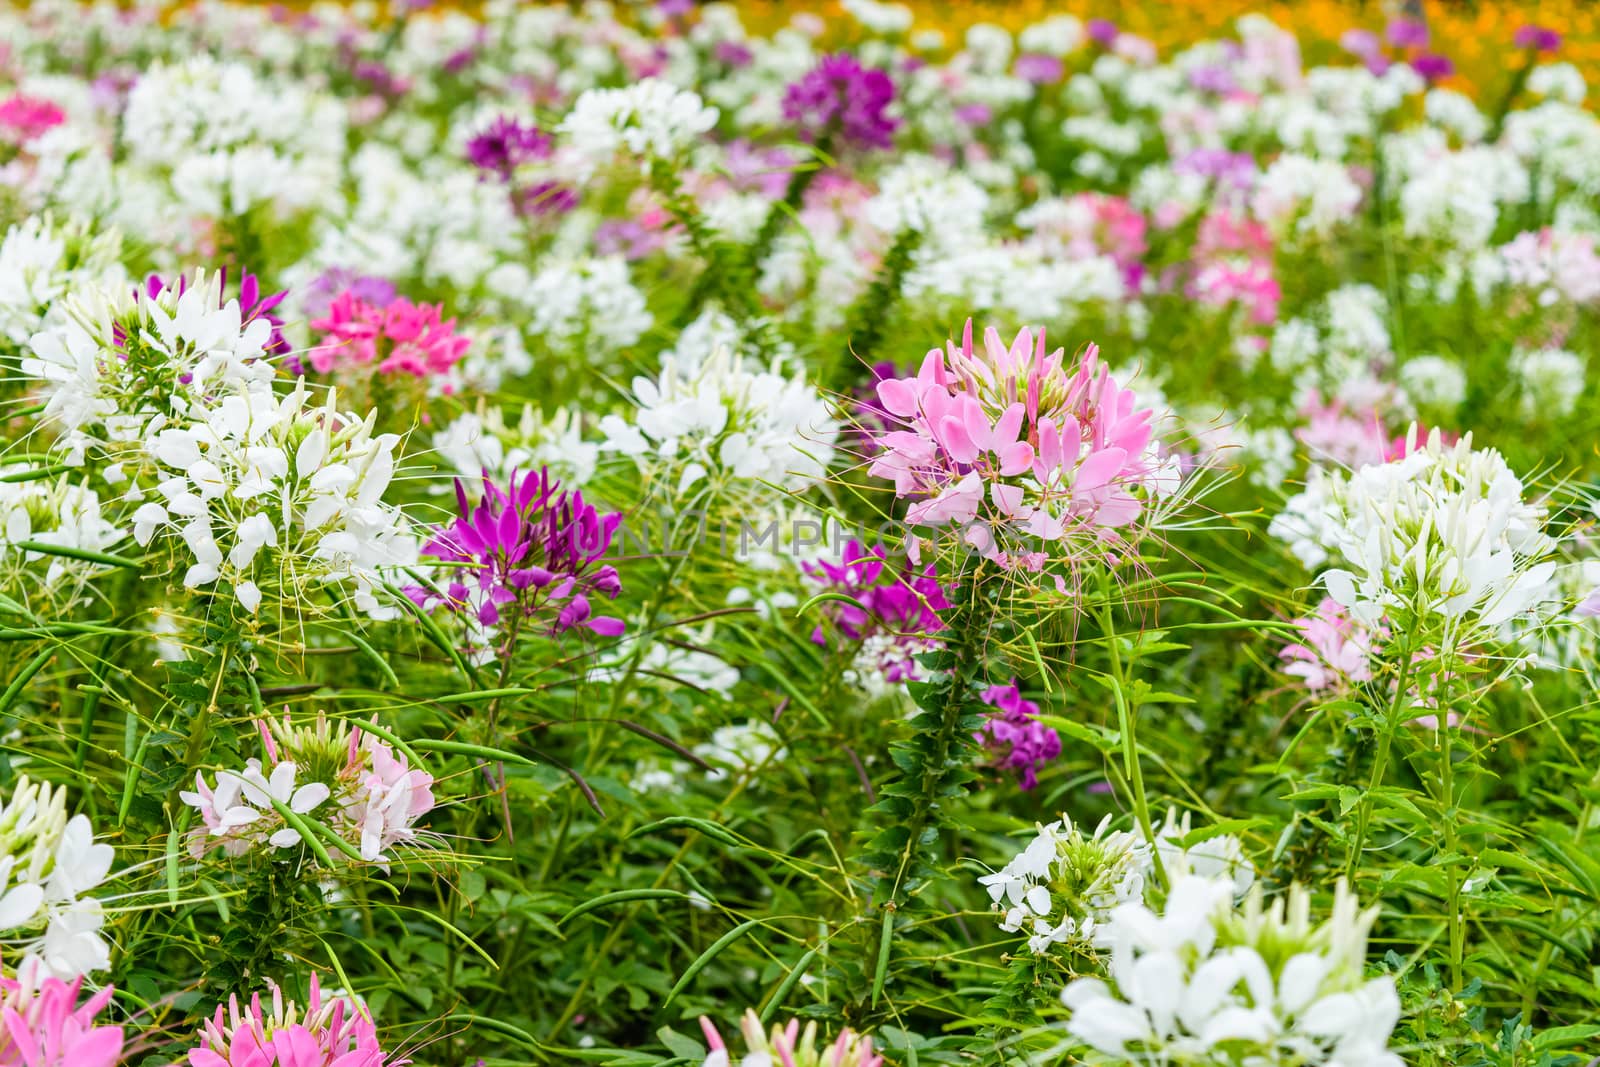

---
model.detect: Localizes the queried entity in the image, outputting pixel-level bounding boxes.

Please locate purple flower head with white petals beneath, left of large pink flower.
[805,541,950,683]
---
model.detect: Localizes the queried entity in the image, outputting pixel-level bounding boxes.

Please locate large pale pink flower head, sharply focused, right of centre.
[870,322,1179,571]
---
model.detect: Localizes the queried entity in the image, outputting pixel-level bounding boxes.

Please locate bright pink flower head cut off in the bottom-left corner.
[0,968,123,1067]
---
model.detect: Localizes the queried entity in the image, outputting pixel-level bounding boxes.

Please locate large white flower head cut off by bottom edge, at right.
[1061,875,1403,1067]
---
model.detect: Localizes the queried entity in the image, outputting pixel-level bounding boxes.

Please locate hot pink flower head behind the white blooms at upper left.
[309,290,472,378]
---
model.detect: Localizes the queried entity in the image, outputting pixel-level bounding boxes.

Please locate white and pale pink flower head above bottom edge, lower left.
[181,718,434,867]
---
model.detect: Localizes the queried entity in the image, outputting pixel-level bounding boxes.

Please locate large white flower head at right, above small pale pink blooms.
[1269,427,1555,637]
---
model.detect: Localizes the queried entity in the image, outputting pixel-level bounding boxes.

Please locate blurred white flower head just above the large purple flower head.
[434,405,600,491]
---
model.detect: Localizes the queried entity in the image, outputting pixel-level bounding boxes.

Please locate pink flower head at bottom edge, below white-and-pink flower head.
[189,974,411,1067]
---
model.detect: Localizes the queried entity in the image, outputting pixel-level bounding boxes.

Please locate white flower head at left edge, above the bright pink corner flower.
[0,776,115,979]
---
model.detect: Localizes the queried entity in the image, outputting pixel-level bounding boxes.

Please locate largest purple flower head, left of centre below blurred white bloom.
[405,469,624,656]
